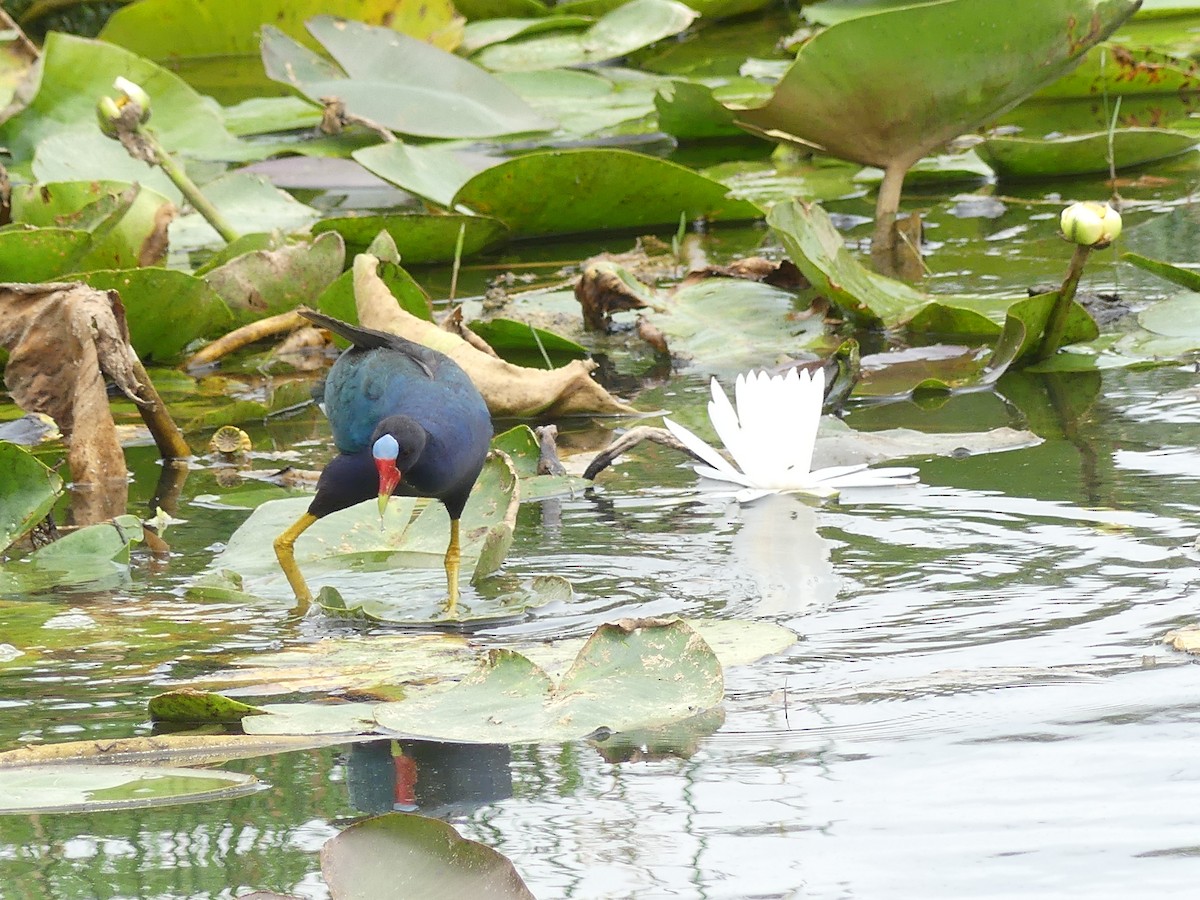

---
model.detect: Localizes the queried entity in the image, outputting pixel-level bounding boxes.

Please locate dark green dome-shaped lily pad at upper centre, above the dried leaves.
[454,149,762,238]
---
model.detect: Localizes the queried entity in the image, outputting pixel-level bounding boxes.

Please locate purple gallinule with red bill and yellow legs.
[275,310,492,610]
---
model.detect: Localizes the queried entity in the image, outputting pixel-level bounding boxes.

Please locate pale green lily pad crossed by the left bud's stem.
[170,172,320,251]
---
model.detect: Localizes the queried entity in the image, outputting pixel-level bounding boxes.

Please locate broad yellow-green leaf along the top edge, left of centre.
[100,0,457,62]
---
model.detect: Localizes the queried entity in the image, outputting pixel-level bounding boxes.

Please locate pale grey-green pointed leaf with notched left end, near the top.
[263,16,554,138]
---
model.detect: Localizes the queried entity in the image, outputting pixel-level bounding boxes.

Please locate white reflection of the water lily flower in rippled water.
[731,493,841,616]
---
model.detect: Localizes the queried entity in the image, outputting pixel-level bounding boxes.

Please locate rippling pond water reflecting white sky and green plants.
[0,157,1200,900]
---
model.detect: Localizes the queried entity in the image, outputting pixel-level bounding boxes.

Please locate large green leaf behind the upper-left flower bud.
[0,31,247,164]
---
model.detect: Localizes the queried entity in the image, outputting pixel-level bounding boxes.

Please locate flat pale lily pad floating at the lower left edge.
[0,763,259,815]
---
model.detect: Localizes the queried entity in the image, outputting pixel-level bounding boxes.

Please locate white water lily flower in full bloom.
[664,368,917,503]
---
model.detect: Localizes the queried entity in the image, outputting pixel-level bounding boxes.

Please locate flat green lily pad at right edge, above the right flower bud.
[976,128,1200,179]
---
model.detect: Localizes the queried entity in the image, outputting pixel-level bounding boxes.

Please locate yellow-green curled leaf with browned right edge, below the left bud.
[12,181,173,269]
